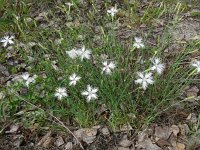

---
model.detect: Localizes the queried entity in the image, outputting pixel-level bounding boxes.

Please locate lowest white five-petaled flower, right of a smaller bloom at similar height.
[81,85,98,102]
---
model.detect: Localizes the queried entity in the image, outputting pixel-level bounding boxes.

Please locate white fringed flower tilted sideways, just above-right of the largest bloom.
[151,57,165,74]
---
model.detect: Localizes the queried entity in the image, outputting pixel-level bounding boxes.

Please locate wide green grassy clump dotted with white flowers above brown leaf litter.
[1,2,200,131]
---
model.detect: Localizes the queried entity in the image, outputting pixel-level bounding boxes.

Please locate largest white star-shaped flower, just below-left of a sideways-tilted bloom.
[135,72,154,90]
